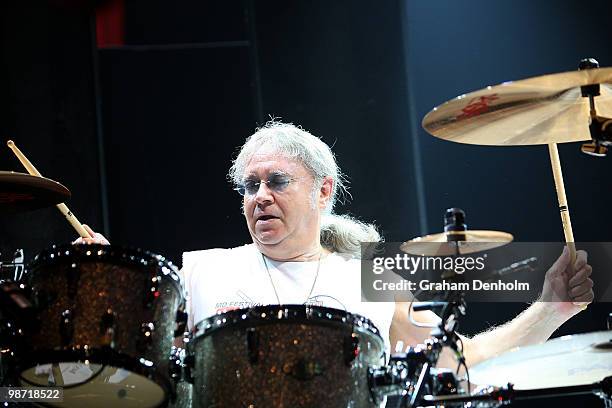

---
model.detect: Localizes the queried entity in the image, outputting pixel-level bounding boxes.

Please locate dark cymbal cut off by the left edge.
[0,171,70,213]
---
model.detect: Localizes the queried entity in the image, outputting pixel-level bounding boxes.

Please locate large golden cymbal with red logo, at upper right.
[422,68,612,146]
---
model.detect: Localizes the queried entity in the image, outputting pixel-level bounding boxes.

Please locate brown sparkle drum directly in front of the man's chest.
[186,305,384,408]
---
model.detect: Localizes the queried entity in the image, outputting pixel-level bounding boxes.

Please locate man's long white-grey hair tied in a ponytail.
[229,120,381,256]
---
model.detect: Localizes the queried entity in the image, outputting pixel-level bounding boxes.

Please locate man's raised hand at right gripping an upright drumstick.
[540,247,595,318]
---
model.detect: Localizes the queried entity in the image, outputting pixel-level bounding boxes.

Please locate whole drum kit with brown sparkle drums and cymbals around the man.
[0,59,612,408]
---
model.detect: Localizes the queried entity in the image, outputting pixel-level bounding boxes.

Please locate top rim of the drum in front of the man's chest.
[189,304,385,346]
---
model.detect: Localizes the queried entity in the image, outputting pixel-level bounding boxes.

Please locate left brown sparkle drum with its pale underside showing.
[18,245,183,408]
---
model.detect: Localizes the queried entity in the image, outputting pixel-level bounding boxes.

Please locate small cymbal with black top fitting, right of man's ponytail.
[400,230,514,256]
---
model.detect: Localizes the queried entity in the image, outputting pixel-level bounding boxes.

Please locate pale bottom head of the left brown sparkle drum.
[20,362,165,408]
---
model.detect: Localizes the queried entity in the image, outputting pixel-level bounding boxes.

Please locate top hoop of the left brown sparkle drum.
[27,244,183,295]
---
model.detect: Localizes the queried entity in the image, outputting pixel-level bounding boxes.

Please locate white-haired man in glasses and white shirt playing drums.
[79,121,594,367]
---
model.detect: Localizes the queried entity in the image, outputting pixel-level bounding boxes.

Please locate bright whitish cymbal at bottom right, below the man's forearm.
[470,331,612,389]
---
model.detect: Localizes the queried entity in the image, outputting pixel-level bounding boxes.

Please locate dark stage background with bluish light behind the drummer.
[0,0,612,405]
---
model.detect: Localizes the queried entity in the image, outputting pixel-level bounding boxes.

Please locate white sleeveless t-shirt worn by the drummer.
[181,244,395,350]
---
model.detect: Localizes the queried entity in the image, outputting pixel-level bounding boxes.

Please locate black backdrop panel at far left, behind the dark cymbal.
[0,0,105,262]
